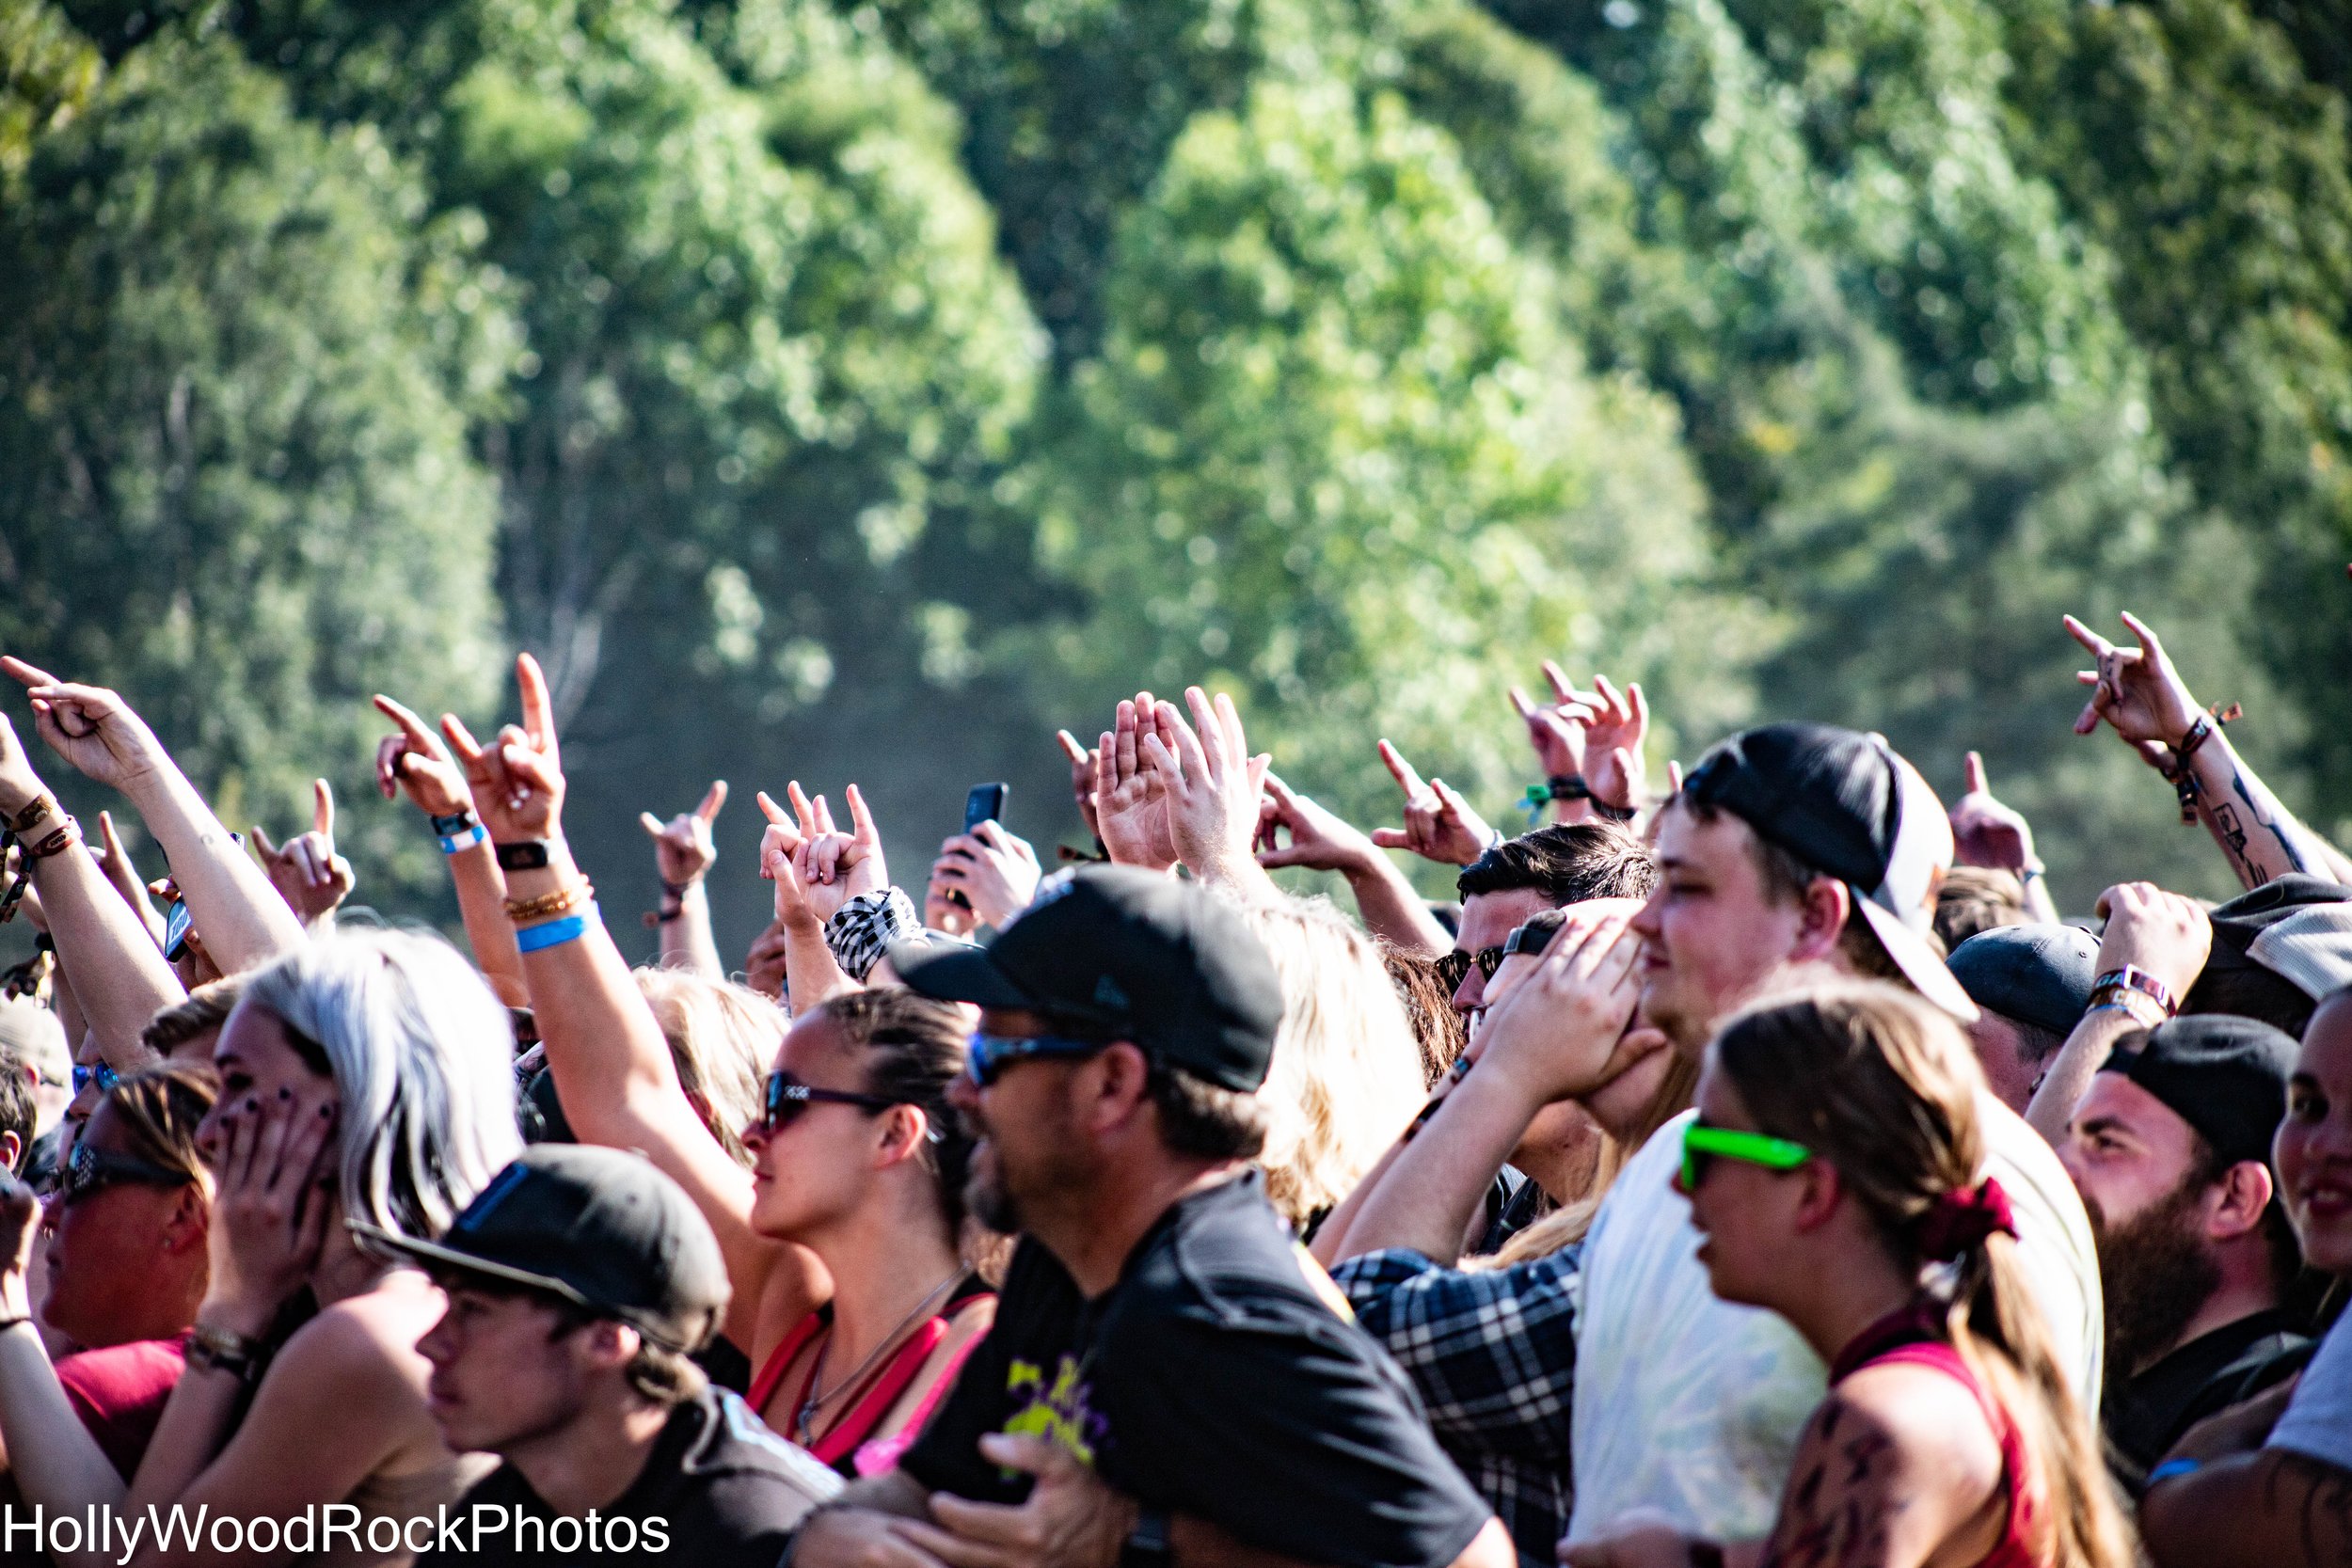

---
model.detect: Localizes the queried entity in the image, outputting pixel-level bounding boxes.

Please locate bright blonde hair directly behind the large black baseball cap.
[1235,895,1425,1229]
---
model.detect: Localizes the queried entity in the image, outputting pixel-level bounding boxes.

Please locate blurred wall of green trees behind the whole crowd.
[0,0,2352,952]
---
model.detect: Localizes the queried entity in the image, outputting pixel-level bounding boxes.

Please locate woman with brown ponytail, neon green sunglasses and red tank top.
[1566,985,2134,1568]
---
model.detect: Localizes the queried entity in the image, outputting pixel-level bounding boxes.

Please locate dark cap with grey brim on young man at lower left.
[351,1143,729,1354]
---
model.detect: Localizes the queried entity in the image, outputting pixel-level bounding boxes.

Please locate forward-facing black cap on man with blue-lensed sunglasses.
[889,865,1282,1093]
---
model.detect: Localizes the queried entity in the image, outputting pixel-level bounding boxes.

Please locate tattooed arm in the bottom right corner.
[2140,1449,2352,1568]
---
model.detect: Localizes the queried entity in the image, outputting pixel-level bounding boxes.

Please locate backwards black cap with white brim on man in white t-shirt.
[1682,724,1976,1022]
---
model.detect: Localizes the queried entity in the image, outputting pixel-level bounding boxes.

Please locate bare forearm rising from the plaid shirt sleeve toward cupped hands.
[1341,1072,1541,1262]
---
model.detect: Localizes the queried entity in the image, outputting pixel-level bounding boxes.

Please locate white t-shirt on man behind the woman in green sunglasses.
[1569,1093,2103,1540]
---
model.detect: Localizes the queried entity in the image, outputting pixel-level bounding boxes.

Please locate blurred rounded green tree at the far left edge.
[0,27,508,879]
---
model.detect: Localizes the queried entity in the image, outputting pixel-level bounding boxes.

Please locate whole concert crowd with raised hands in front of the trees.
[0,616,2352,1568]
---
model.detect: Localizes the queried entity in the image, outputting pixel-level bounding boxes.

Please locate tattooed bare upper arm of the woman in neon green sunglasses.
[1762,1364,2009,1568]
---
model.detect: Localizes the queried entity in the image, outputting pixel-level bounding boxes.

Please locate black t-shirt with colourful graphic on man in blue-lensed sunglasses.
[901,1173,1491,1568]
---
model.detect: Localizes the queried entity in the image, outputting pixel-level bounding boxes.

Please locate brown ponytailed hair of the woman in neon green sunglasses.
[1715,985,2134,1568]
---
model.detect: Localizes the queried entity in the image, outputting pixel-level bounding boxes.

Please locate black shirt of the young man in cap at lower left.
[417,1389,842,1568]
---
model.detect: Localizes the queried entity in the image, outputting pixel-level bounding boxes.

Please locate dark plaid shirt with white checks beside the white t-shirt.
[1331,1242,1585,1568]
